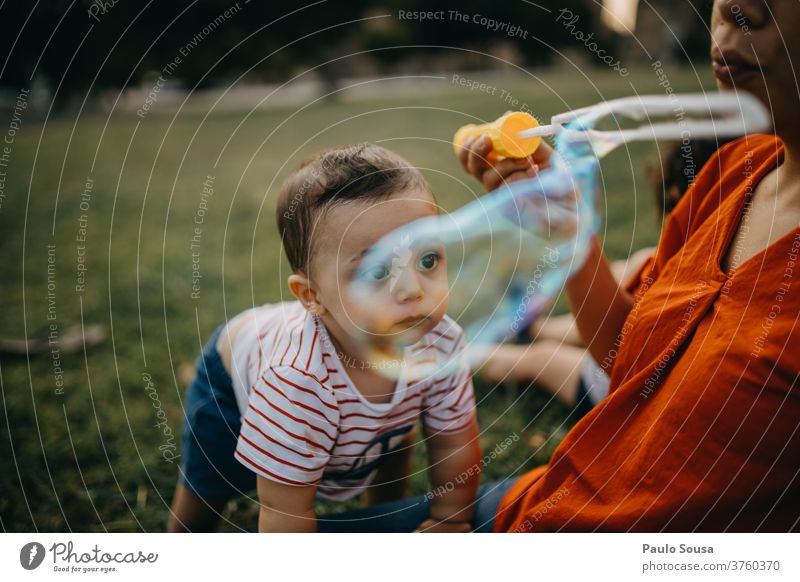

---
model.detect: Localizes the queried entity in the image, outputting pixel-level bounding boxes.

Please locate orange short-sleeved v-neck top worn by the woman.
[494,135,800,532]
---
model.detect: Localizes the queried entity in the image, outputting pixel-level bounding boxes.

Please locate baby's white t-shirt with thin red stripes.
[231,301,475,500]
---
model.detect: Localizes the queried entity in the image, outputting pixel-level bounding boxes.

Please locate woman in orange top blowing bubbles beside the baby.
[320,0,800,532]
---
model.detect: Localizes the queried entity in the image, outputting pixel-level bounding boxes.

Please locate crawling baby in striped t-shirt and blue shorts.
[169,144,480,532]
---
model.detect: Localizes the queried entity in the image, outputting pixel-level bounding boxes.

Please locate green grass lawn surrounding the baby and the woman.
[0,65,712,531]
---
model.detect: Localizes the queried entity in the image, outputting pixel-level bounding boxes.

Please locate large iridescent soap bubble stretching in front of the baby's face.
[348,121,599,380]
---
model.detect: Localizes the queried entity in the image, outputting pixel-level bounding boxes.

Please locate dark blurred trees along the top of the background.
[0,0,706,109]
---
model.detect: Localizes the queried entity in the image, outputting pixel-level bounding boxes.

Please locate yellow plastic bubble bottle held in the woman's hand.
[453,111,542,158]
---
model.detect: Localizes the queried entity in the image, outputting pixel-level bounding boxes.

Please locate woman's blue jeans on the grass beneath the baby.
[317,478,516,533]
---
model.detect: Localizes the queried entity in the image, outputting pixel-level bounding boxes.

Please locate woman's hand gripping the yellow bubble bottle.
[458,135,553,192]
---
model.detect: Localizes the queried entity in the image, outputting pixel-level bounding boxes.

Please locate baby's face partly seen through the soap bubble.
[309,190,447,347]
